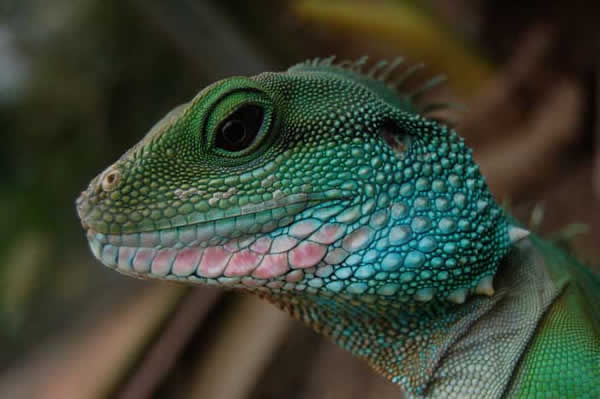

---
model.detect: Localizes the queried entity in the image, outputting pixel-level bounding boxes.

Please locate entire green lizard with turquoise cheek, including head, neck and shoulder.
[77,58,600,399]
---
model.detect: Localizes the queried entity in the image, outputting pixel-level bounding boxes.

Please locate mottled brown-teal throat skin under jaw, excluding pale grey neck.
[264,288,499,397]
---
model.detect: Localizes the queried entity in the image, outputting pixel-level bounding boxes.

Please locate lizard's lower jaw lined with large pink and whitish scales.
[88,216,341,290]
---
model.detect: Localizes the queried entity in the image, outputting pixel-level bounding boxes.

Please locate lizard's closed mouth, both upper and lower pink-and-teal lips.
[87,193,354,288]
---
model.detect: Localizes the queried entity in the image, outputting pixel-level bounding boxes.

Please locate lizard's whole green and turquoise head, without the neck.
[77,60,509,306]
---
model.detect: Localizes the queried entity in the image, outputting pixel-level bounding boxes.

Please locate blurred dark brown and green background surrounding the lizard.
[0,0,600,399]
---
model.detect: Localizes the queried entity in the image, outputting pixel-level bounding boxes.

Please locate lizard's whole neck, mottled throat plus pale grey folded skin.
[264,239,560,398]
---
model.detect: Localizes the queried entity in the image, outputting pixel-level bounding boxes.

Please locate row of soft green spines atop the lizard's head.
[289,55,460,120]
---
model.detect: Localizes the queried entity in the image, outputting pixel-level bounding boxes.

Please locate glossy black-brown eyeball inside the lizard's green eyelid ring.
[215,105,263,152]
